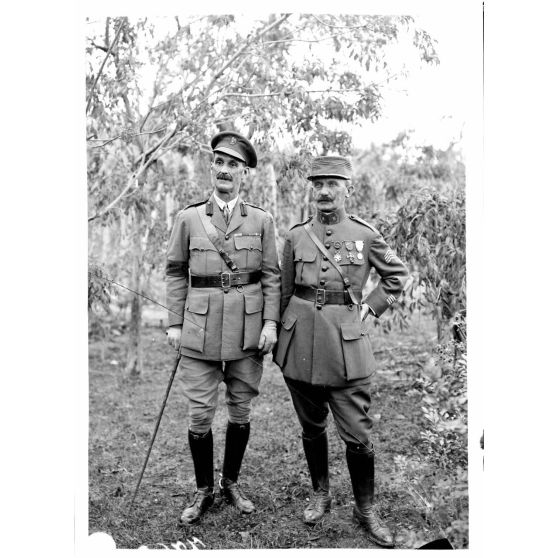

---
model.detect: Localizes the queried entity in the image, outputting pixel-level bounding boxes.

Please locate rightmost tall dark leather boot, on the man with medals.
[346,444,395,548]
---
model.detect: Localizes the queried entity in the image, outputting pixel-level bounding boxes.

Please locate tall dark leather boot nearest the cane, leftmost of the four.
[180,430,214,524]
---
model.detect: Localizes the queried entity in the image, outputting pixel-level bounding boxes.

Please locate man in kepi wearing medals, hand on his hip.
[274,156,408,547]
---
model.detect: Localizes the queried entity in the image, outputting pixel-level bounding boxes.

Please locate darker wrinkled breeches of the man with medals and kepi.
[285,378,373,451]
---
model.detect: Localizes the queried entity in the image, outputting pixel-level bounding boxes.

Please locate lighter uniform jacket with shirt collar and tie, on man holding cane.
[166,195,280,360]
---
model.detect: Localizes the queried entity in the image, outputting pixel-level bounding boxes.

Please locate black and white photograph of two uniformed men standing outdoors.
[83,2,484,551]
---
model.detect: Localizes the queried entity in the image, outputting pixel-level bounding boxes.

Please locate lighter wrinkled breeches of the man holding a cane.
[178,355,263,434]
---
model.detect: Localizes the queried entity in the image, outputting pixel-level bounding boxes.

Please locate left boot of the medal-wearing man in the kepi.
[302,431,331,525]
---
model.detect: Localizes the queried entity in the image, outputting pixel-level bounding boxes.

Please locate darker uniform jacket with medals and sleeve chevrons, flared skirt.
[274,210,408,386]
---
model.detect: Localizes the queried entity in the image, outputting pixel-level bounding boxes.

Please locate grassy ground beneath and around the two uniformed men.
[89,318,467,549]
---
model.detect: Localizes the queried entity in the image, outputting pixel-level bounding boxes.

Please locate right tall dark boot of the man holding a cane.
[219,422,256,513]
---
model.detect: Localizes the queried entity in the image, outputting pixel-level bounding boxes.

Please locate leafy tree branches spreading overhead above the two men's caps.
[86,14,437,222]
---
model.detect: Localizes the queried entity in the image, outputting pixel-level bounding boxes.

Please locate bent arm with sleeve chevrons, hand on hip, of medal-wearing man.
[364,233,409,316]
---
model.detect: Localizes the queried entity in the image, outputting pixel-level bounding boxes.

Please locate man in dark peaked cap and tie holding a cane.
[166,132,280,524]
